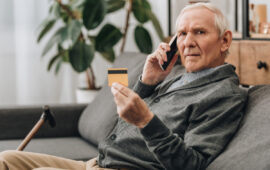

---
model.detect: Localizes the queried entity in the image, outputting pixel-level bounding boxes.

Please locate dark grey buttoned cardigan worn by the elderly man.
[98,65,247,170]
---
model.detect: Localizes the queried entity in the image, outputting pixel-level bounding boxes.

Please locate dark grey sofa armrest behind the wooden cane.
[0,104,87,140]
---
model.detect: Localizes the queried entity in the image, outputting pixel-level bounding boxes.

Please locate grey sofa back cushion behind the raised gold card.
[79,53,146,145]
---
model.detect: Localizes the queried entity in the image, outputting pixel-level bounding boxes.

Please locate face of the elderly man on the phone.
[177,8,225,72]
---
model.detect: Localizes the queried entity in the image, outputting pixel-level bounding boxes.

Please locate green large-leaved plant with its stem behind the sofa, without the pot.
[37,0,164,101]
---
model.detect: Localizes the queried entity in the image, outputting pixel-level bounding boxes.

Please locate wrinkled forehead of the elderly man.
[176,7,217,31]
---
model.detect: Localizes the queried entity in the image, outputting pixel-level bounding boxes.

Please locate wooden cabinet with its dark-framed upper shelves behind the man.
[226,0,270,85]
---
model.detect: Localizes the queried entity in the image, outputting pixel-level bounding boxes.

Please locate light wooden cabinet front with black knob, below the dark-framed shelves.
[226,40,270,85]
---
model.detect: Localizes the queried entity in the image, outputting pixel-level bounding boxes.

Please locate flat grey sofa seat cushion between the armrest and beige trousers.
[0,137,98,161]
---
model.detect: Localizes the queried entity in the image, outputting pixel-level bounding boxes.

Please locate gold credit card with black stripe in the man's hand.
[108,68,128,87]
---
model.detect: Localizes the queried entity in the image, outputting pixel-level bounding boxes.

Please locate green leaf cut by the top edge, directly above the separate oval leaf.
[132,0,151,24]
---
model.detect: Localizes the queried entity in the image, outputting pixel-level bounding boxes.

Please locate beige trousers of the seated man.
[0,151,124,170]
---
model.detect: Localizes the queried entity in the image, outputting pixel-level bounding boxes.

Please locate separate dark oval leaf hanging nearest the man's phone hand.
[134,26,153,54]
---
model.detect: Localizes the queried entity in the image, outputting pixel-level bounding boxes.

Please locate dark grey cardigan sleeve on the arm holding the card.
[141,95,246,170]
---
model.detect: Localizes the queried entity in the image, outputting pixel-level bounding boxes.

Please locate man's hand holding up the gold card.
[111,83,154,128]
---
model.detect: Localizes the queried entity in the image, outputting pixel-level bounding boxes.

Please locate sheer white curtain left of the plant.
[0,0,78,105]
